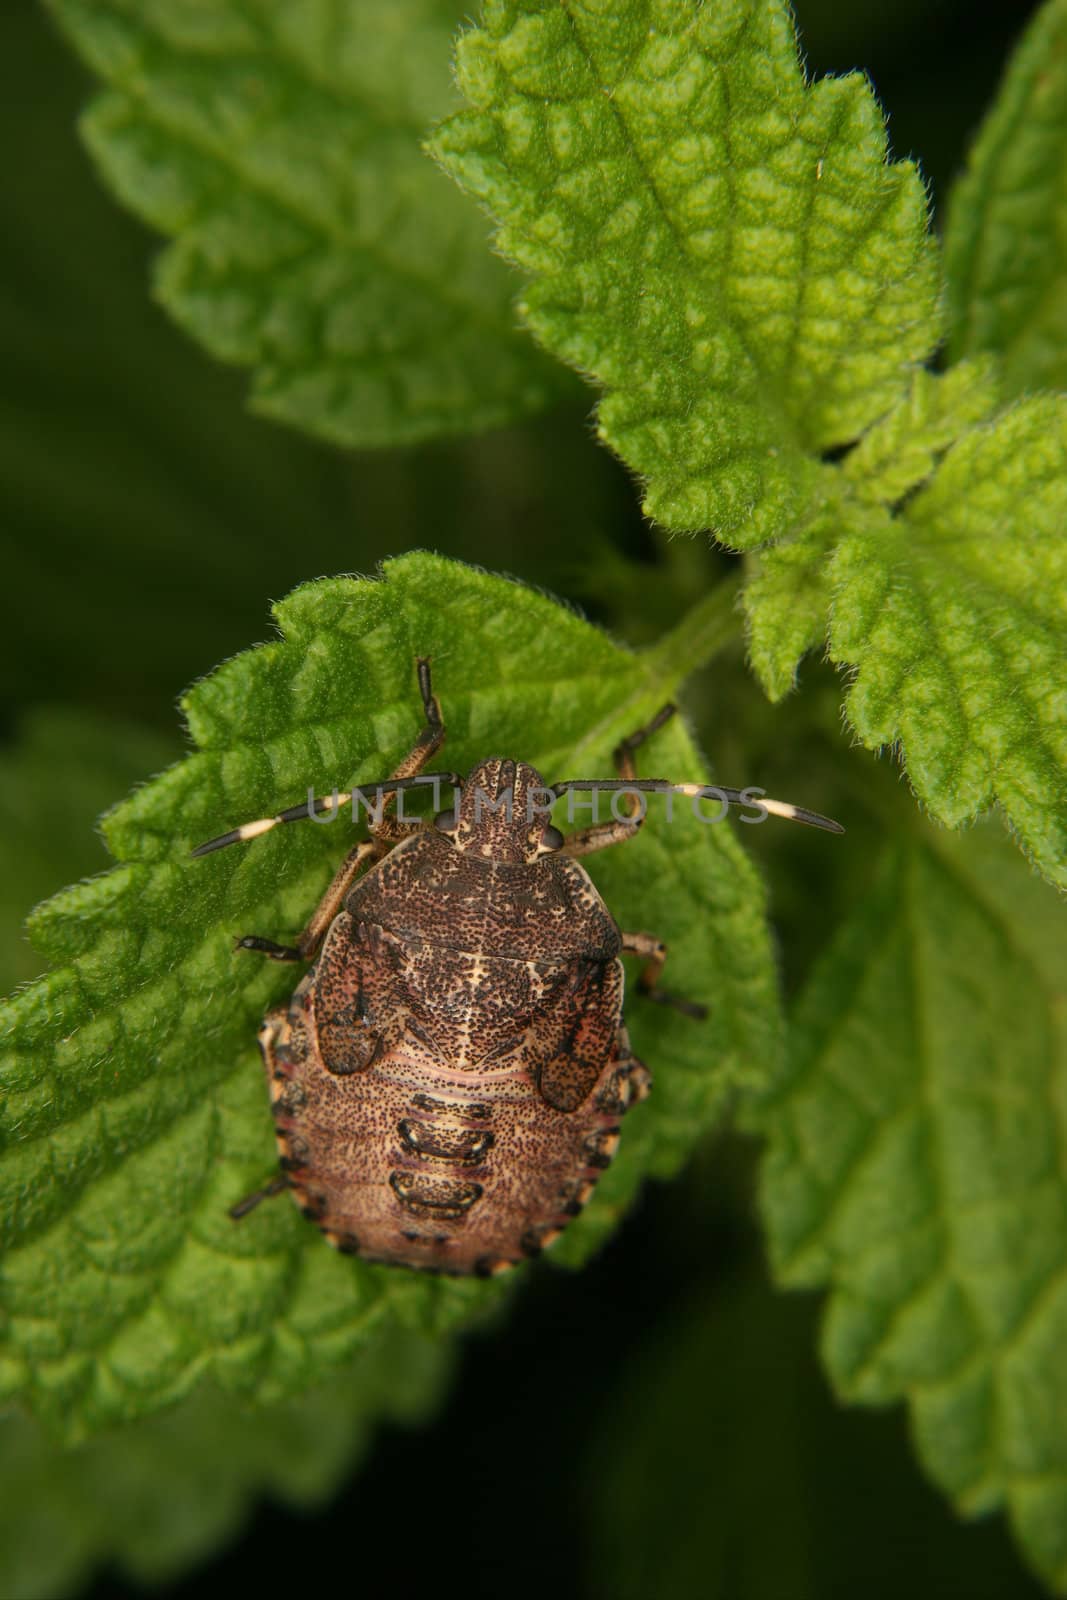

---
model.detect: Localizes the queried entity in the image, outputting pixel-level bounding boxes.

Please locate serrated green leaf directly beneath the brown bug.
[0,555,777,1429]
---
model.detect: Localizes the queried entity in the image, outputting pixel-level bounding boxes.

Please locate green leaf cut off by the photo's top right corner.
[945,0,1067,394]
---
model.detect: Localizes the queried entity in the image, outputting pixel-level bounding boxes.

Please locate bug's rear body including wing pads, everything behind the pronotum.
[262,925,648,1274]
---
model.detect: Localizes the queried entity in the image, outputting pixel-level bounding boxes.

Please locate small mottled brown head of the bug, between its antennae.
[437,757,563,862]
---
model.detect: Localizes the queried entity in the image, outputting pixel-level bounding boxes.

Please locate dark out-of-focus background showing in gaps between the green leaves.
[0,0,1037,1600]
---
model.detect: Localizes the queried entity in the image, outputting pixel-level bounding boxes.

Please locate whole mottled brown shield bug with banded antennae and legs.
[195,659,837,1275]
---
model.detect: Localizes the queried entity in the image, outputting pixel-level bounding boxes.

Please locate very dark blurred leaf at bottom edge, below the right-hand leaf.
[585,1272,1040,1600]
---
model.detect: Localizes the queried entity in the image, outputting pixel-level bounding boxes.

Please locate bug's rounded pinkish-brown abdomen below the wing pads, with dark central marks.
[265,1019,646,1274]
